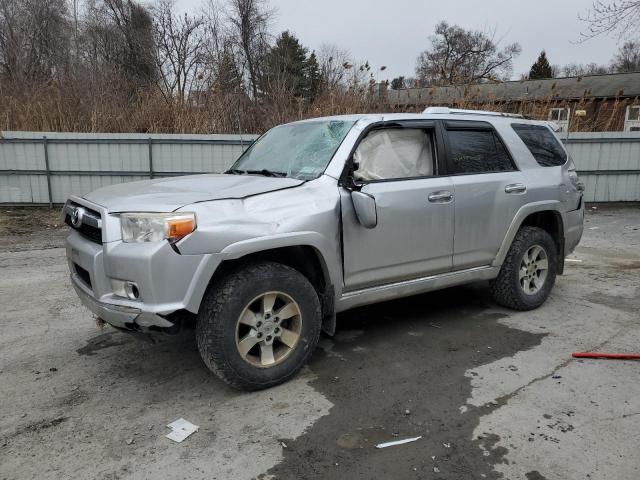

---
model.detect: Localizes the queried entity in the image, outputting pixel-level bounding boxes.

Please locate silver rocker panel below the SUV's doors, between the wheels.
[336,267,500,312]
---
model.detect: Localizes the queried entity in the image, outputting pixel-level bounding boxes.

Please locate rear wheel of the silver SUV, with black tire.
[490,227,558,310]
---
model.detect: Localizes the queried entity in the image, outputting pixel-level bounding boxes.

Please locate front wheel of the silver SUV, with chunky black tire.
[196,262,322,390]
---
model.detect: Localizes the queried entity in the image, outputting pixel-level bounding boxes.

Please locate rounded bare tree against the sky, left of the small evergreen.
[416,22,521,85]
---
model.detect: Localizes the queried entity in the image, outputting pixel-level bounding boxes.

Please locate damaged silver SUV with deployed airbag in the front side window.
[64,108,584,390]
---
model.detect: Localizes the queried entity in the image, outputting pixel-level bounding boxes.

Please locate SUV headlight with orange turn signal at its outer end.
[120,212,196,242]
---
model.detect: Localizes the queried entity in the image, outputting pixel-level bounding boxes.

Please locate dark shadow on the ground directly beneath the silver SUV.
[76,285,499,392]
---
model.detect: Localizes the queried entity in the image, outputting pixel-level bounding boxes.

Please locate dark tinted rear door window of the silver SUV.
[447,130,514,173]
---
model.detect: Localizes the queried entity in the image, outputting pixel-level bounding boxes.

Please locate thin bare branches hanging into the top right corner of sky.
[580,0,640,41]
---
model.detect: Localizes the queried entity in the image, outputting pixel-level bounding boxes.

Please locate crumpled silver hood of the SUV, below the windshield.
[84,174,304,213]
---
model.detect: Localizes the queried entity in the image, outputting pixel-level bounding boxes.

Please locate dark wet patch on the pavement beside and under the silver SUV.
[268,284,543,480]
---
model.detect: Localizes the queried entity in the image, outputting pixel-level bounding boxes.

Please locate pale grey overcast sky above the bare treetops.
[176,0,618,80]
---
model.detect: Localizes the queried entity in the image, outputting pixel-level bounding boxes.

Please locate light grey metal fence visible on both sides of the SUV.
[0,132,640,205]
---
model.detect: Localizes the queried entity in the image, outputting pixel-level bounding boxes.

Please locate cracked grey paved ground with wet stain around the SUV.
[0,206,640,480]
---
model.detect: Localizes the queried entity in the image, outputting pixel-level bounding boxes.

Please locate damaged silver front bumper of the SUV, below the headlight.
[65,199,221,332]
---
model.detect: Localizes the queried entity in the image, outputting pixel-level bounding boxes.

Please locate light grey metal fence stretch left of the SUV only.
[0,132,256,206]
